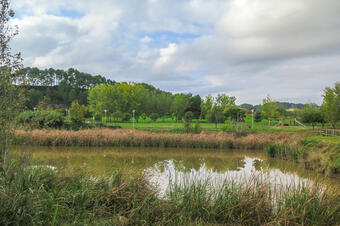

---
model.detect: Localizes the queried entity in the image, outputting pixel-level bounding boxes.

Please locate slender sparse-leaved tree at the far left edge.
[0,0,24,168]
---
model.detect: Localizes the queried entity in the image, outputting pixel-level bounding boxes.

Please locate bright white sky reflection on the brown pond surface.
[146,156,313,195]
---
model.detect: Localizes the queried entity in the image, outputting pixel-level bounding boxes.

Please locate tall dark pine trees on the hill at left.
[18,67,115,109]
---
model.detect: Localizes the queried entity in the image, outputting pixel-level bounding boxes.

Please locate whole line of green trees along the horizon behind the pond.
[15,67,340,127]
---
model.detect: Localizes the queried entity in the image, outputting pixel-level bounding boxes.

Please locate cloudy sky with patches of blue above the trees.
[12,0,340,104]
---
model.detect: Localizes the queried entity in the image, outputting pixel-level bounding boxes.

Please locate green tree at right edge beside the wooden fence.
[321,82,340,128]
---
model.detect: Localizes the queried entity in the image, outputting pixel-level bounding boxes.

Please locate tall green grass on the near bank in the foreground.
[0,163,340,225]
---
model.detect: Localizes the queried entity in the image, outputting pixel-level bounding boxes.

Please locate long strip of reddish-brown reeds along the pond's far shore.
[13,129,301,149]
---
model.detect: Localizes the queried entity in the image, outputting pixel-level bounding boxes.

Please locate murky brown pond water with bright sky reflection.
[10,146,340,192]
